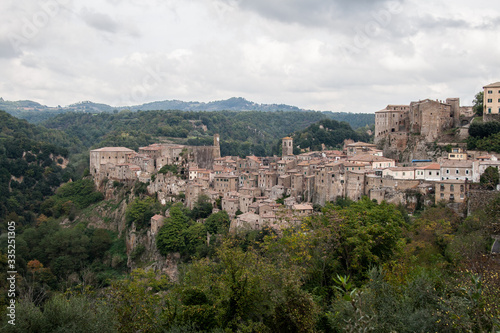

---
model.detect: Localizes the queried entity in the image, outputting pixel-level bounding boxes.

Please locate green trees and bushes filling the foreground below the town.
[3,196,500,332]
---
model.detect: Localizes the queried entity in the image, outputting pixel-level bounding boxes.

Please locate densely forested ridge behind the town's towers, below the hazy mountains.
[43,111,368,156]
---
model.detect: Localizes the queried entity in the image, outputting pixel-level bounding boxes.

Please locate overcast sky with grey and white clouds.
[0,0,500,112]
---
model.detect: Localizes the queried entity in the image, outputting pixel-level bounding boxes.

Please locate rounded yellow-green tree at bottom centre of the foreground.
[179,240,318,332]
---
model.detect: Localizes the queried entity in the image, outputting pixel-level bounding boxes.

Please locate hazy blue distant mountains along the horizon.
[0,97,375,129]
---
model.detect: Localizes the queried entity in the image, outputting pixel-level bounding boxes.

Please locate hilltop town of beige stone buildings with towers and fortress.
[90,85,500,229]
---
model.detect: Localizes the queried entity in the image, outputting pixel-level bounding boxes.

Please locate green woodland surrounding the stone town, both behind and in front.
[0,107,500,332]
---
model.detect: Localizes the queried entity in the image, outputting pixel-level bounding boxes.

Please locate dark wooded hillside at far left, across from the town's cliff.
[0,111,80,224]
